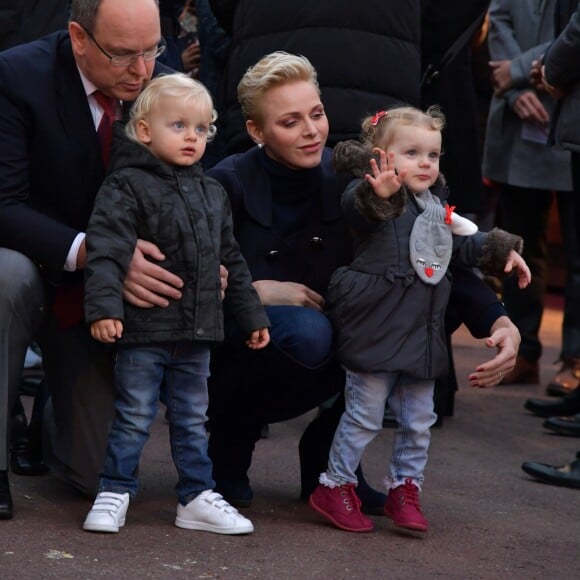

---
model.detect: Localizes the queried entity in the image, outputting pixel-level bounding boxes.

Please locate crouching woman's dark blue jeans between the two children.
[209,306,344,494]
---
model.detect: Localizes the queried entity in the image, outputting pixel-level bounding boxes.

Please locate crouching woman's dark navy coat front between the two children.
[206,147,352,295]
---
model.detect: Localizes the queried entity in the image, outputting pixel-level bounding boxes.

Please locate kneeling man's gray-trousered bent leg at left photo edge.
[0,248,43,519]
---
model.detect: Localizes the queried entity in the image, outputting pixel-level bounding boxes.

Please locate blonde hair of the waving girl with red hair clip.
[361,105,445,150]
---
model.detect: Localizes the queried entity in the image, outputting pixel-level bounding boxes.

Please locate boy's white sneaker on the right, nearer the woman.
[175,489,254,534]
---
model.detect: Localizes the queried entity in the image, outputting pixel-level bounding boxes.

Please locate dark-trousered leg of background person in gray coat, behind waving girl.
[500,184,552,385]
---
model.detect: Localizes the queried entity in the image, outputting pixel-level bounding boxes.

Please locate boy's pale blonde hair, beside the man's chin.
[125,73,217,143]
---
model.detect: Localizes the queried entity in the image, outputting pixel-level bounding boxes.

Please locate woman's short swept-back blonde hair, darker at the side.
[238,51,320,123]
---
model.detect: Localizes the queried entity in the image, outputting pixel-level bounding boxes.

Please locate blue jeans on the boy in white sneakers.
[99,341,215,505]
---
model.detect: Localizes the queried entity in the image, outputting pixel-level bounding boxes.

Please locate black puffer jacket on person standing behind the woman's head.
[210,0,421,152]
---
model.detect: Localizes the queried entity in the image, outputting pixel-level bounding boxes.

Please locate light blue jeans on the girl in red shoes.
[323,369,437,489]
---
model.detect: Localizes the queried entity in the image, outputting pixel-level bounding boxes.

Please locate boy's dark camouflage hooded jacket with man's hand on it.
[85,127,269,344]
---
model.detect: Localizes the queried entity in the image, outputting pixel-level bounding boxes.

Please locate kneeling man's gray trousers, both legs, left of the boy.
[0,248,114,495]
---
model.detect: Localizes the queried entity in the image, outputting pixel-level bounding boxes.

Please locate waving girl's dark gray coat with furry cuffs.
[327,143,522,379]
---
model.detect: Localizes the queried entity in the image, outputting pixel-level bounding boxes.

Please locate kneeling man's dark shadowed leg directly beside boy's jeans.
[39,312,115,496]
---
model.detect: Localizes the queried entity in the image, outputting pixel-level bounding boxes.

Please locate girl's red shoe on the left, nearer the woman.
[308,483,374,532]
